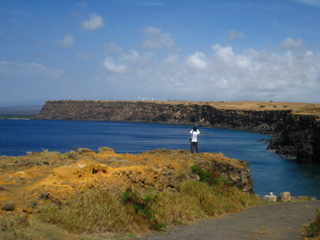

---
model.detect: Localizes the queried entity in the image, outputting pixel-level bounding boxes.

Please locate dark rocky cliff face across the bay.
[37,101,320,162]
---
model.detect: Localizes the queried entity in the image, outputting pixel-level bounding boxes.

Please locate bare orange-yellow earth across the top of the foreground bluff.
[0,148,248,218]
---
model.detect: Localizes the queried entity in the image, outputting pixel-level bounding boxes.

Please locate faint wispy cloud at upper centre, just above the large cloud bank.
[142,26,174,49]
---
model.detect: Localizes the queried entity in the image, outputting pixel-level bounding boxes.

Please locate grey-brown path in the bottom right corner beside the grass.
[138,201,320,240]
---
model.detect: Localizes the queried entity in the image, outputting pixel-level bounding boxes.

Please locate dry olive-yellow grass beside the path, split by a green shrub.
[41,180,261,237]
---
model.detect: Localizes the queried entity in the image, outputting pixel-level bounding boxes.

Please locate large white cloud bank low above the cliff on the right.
[100,37,320,102]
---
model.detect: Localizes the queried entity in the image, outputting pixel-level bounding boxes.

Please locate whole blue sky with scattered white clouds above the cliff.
[0,0,320,106]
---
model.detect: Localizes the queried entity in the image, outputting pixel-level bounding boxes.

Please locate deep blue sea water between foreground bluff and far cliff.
[0,119,320,199]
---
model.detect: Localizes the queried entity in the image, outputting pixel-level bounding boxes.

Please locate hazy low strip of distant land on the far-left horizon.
[0,105,42,118]
